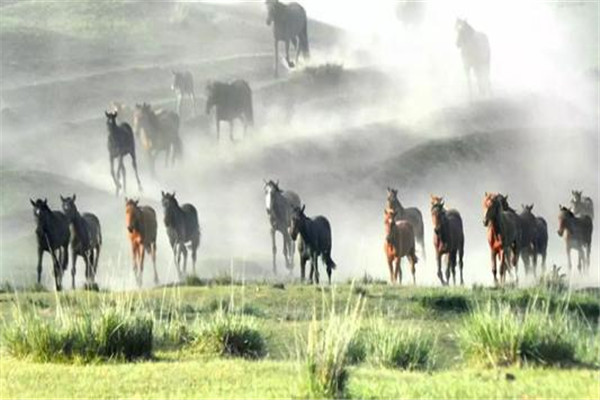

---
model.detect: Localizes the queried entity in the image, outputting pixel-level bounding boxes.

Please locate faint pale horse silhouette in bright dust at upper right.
[455,18,492,97]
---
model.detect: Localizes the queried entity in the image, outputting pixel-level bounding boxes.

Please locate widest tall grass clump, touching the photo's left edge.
[1,302,153,362]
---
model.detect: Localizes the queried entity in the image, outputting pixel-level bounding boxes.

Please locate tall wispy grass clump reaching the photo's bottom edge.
[299,292,364,398]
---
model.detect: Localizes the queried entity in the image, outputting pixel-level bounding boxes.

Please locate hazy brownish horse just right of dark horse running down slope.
[133,103,183,175]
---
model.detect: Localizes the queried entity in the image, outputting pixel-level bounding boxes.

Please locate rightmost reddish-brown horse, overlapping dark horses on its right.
[483,192,521,284]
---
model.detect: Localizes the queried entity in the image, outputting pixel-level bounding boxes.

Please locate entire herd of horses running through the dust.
[31,0,593,290]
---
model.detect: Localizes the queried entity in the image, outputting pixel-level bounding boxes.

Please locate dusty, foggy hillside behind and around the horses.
[0,0,600,289]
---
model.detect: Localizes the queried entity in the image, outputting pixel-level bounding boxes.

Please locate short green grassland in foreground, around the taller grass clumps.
[0,283,600,398]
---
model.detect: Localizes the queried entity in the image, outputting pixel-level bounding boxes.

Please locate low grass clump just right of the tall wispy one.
[365,319,436,370]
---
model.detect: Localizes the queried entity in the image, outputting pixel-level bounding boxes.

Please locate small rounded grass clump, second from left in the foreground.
[194,310,266,359]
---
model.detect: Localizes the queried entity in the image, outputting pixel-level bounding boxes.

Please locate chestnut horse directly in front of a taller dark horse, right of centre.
[383,208,418,285]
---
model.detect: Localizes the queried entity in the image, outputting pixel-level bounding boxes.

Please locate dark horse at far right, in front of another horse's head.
[558,205,593,272]
